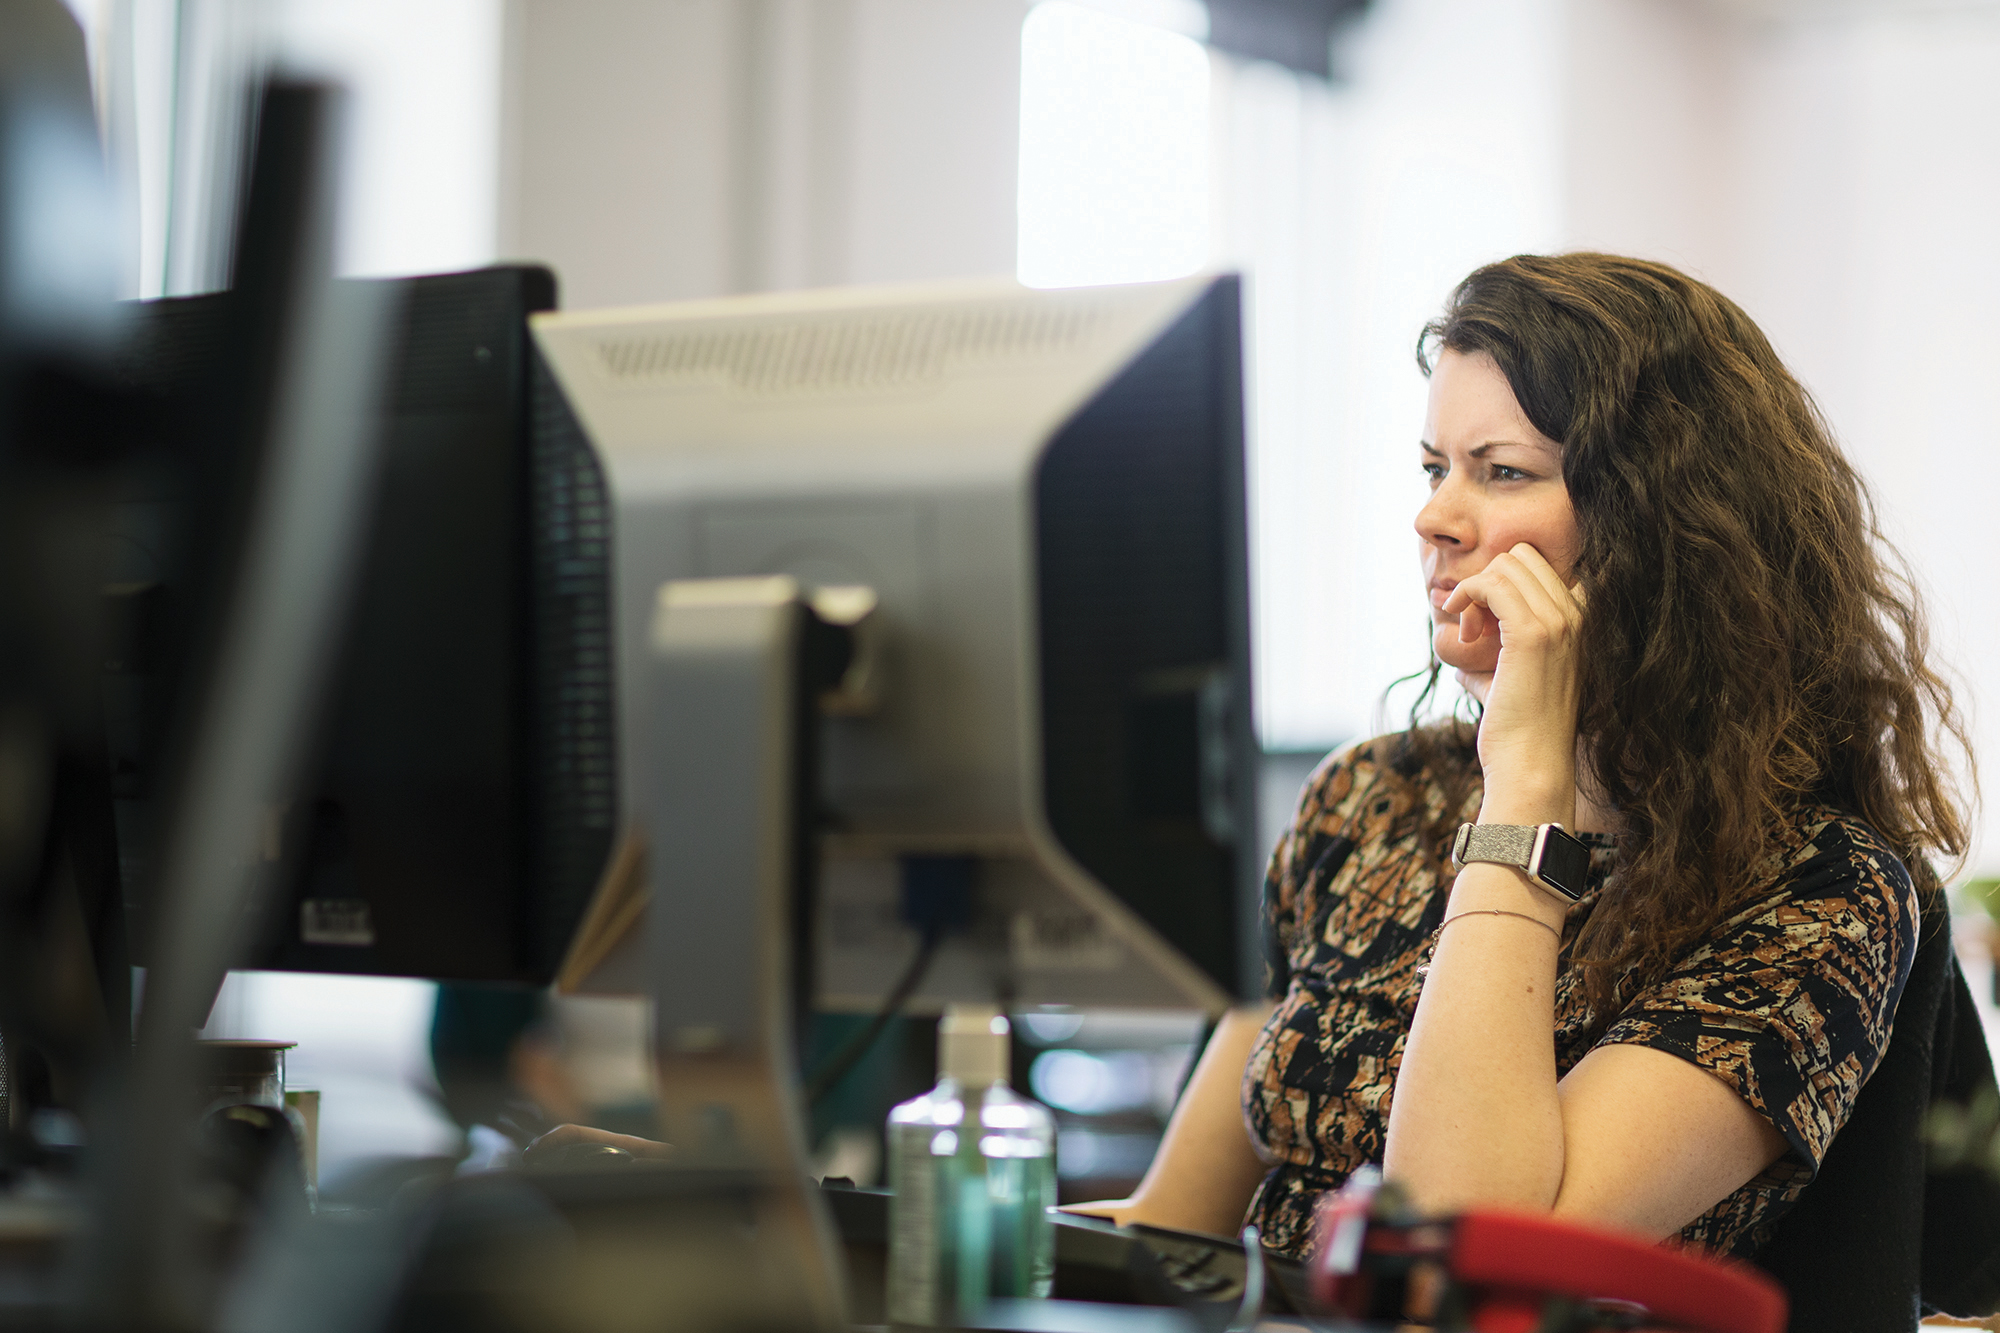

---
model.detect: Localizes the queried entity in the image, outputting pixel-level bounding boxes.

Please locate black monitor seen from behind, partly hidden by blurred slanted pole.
[106,266,616,985]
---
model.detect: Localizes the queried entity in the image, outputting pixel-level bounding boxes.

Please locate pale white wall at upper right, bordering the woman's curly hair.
[1566,0,2000,873]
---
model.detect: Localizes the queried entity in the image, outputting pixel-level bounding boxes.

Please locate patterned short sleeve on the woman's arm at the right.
[1598,817,1918,1187]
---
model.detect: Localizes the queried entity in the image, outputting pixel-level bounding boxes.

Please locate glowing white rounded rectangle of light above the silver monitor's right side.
[1018,0,1210,286]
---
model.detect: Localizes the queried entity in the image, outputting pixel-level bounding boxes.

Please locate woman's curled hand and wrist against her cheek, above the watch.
[1444,542,1584,825]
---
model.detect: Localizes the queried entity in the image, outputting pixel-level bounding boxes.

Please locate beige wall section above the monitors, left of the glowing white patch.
[500,0,1024,308]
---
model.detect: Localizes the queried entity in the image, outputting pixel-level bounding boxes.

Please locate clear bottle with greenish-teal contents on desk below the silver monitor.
[888,1005,1056,1325]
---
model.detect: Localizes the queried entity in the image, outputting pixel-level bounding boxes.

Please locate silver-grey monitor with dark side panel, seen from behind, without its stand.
[532,276,1262,1009]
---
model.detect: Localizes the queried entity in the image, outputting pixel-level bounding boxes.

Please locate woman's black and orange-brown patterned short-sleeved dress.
[1244,737,1918,1257]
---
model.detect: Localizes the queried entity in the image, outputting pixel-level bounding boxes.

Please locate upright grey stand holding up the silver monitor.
[634,576,846,1327]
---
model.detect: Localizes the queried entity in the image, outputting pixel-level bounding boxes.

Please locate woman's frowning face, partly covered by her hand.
[1416,350,1578,677]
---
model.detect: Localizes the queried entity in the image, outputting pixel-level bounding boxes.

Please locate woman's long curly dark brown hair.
[1416,254,1972,1019]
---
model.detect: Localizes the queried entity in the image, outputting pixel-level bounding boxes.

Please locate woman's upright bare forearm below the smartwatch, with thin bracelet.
[1384,844,1564,1213]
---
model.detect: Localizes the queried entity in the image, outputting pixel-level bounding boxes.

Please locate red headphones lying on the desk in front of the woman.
[1312,1187,1788,1333]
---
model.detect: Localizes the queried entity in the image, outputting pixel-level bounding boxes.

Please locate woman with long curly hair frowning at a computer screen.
[1094,254,1966,1255]
